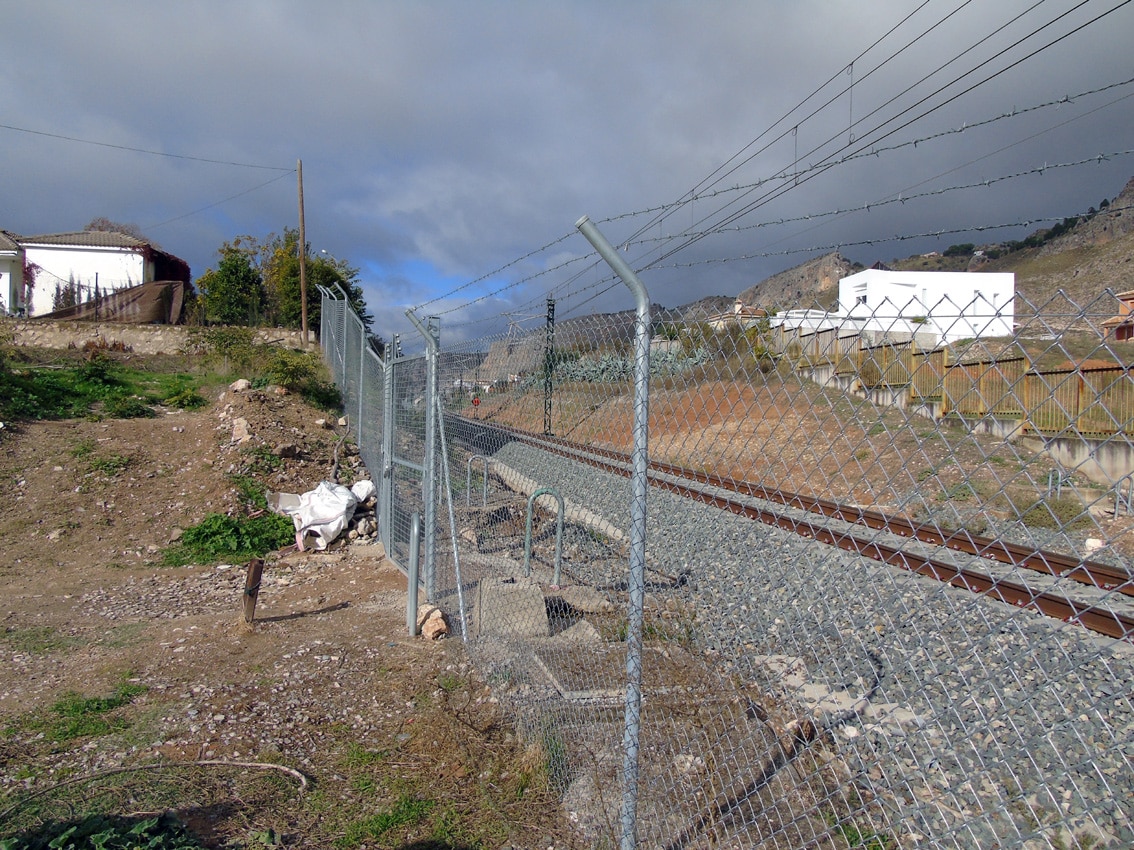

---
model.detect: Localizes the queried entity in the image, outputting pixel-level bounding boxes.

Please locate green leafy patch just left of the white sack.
[162,513,295,567]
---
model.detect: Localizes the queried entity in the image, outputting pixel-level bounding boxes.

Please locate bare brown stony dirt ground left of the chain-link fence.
[0,380,572,850]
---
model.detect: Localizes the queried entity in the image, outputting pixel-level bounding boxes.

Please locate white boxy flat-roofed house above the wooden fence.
[838,269,1016,342]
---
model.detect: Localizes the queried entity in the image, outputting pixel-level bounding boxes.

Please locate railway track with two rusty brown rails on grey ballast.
[450,415,1134,643]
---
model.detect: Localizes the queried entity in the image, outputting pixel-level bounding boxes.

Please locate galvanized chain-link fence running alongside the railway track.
[322,265,1134,850]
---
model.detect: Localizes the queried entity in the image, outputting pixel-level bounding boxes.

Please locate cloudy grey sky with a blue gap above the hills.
[0,0,1134,337]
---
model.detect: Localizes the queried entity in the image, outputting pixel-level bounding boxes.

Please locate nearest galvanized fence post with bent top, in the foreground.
[575,215,650,850]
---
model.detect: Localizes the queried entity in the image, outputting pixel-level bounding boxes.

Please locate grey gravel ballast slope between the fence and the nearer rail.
[485,442,1134,848]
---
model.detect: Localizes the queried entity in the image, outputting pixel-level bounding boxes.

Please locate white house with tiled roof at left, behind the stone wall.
[9,230,189,316]
